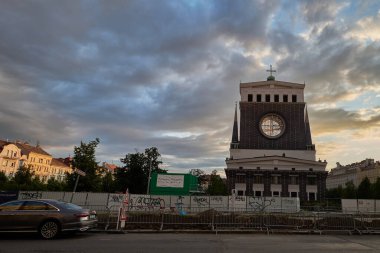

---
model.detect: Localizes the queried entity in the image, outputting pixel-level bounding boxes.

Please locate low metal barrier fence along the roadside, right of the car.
[106,209,380,234]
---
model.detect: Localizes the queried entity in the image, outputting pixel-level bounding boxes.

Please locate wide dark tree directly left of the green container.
[115,147,166,194]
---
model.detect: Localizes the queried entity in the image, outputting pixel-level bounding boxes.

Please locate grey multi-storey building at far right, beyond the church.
[326,158,380,189]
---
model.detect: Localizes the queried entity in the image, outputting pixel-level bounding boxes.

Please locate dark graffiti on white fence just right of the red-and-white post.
[129,196,165,211]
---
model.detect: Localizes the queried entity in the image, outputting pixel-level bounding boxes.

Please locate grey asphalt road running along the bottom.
[0,233,380,253]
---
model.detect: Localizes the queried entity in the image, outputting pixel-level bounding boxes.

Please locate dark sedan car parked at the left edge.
[0,199,97,239]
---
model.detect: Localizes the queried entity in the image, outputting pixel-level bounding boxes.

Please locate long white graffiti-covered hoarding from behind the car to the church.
[18,191,300,213]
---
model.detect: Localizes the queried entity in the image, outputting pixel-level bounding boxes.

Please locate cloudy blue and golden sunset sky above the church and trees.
[0,0,380,173]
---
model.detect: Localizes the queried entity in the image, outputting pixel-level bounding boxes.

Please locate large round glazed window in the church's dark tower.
[259,113,285,139]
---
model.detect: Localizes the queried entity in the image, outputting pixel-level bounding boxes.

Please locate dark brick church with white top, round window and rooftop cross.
[225,66,327,201]
